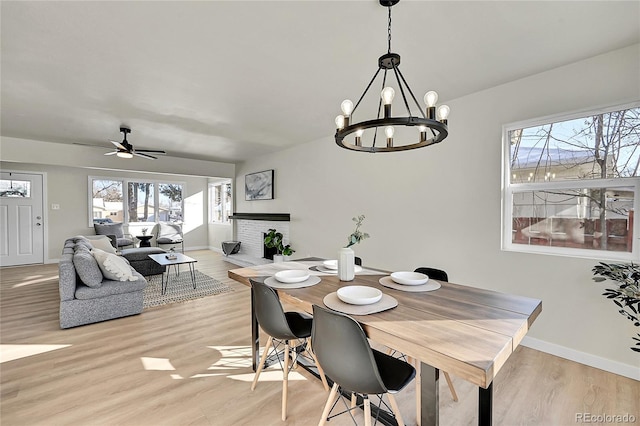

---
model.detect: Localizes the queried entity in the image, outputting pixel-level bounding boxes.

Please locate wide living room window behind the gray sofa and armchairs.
[89,177,183,226]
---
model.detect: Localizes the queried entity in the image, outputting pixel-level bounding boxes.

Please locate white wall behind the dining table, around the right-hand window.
[235,45,640,379]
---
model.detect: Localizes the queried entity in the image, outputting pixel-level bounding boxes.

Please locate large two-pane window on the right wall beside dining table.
[503,104,640,260]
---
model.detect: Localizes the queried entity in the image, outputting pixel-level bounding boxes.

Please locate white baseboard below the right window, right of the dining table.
[521,336,640,381]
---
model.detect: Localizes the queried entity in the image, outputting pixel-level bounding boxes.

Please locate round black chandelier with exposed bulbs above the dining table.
[336,0,449,152]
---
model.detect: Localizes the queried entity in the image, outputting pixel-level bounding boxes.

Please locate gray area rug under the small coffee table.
[144,267,233,309]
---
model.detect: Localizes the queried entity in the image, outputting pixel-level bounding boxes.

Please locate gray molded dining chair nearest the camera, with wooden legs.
[311,305,416,426]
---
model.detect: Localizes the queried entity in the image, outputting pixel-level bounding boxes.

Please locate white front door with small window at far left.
[0,171,44,266]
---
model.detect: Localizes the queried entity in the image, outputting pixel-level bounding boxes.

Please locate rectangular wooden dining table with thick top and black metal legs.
[228,258,542,426]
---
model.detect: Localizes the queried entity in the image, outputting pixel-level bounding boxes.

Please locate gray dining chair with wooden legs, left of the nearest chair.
[250,280,329,421]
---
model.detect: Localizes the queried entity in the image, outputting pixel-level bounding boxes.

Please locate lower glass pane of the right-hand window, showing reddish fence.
[511,187,635,253]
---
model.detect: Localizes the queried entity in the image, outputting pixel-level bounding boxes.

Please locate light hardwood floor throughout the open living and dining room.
[0,250,640,426]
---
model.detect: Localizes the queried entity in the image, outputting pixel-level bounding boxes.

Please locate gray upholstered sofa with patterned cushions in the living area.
[58,237,147,328]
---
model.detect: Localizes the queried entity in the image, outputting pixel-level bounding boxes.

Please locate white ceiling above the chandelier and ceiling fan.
[0,0,640,162]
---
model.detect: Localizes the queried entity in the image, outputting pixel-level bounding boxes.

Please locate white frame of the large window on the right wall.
[501,102,640,262]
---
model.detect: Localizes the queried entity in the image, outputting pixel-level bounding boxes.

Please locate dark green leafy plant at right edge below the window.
[592,262,640,352]
